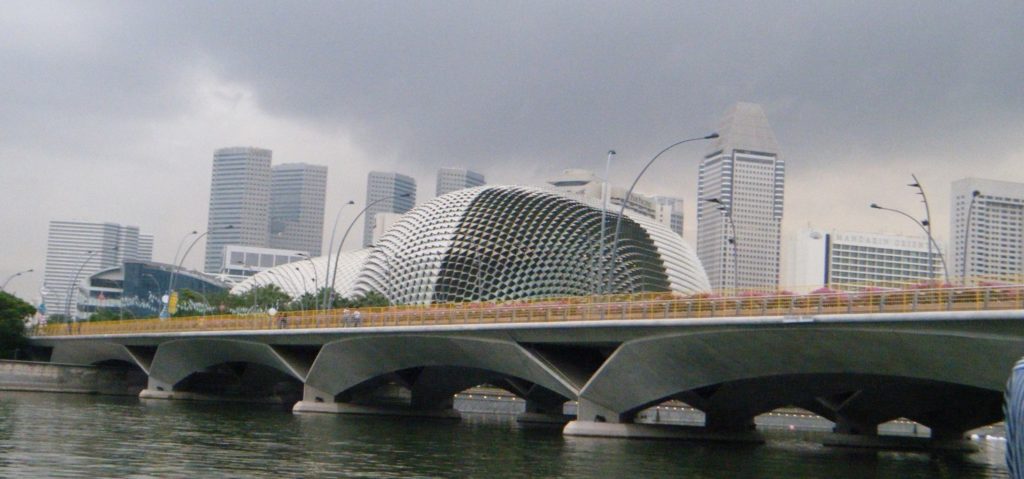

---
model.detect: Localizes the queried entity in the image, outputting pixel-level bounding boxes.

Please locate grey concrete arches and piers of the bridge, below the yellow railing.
[37,315,1024,441]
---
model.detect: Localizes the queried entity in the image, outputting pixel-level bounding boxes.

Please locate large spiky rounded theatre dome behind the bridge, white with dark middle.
[351,185,711,304]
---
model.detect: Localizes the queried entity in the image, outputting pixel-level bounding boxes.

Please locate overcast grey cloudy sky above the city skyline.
[0,0,1024,298]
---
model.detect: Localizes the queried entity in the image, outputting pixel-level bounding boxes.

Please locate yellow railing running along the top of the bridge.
[33,286,1024,336]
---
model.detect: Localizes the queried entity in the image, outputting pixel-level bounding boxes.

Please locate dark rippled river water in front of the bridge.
[0,392,1008,479]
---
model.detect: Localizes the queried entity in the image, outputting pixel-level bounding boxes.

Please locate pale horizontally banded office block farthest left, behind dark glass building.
[43,221,153,314]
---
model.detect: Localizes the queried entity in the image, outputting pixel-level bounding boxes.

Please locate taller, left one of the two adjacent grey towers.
[203,146,272,273]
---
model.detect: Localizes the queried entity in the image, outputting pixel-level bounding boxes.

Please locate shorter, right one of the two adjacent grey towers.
[270,163,327,256]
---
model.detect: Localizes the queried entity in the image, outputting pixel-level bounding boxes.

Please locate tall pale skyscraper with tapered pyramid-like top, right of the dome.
[697,102,785,290]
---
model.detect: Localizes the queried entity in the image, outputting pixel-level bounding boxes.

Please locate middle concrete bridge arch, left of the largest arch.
[306,335,578,407]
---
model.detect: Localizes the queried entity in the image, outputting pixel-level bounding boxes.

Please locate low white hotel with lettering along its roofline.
[785,228,942,293]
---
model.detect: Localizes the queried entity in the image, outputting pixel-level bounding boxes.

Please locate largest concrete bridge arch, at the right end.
[581,324,1024,429]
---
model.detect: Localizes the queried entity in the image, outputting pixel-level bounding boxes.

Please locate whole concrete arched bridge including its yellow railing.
[32,287,1024,441]
